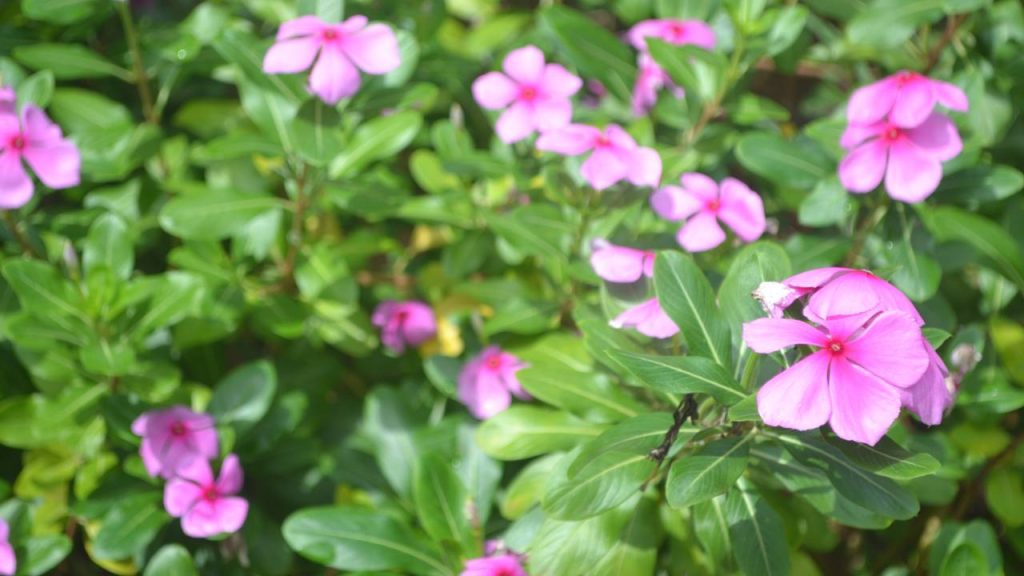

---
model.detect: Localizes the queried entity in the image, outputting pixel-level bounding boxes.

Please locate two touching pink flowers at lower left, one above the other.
[131,406,249,538]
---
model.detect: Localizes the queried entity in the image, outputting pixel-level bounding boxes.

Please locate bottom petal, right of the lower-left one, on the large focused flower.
[828,358,900,446]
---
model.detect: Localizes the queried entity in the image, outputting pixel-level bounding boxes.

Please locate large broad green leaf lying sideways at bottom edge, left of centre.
[283,507,454,576]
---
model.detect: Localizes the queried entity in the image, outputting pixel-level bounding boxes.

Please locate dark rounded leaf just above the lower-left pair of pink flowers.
[207,360,278,433]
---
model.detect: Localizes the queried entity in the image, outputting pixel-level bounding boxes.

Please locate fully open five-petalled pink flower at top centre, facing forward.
[473,46,583,143]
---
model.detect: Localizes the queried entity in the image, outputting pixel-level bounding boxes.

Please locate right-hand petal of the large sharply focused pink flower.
[844,312,929,388]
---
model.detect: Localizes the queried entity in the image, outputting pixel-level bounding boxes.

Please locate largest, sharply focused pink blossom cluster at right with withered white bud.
[743,268,952,445]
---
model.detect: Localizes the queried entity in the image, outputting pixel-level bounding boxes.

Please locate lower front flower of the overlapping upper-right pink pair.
[839,114,964,203]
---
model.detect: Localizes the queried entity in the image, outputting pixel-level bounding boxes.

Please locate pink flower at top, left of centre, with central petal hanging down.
[263,15,401,105]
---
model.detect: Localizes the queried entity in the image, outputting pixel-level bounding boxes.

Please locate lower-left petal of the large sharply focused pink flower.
[758,352,831,430]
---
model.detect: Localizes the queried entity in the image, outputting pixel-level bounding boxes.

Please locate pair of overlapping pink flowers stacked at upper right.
[839,72,968,204]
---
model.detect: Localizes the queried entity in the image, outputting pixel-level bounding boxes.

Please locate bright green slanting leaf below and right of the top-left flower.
[330,111,423,178]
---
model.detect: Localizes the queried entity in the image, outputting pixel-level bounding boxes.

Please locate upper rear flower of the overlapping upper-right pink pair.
[846,71,968,128]
